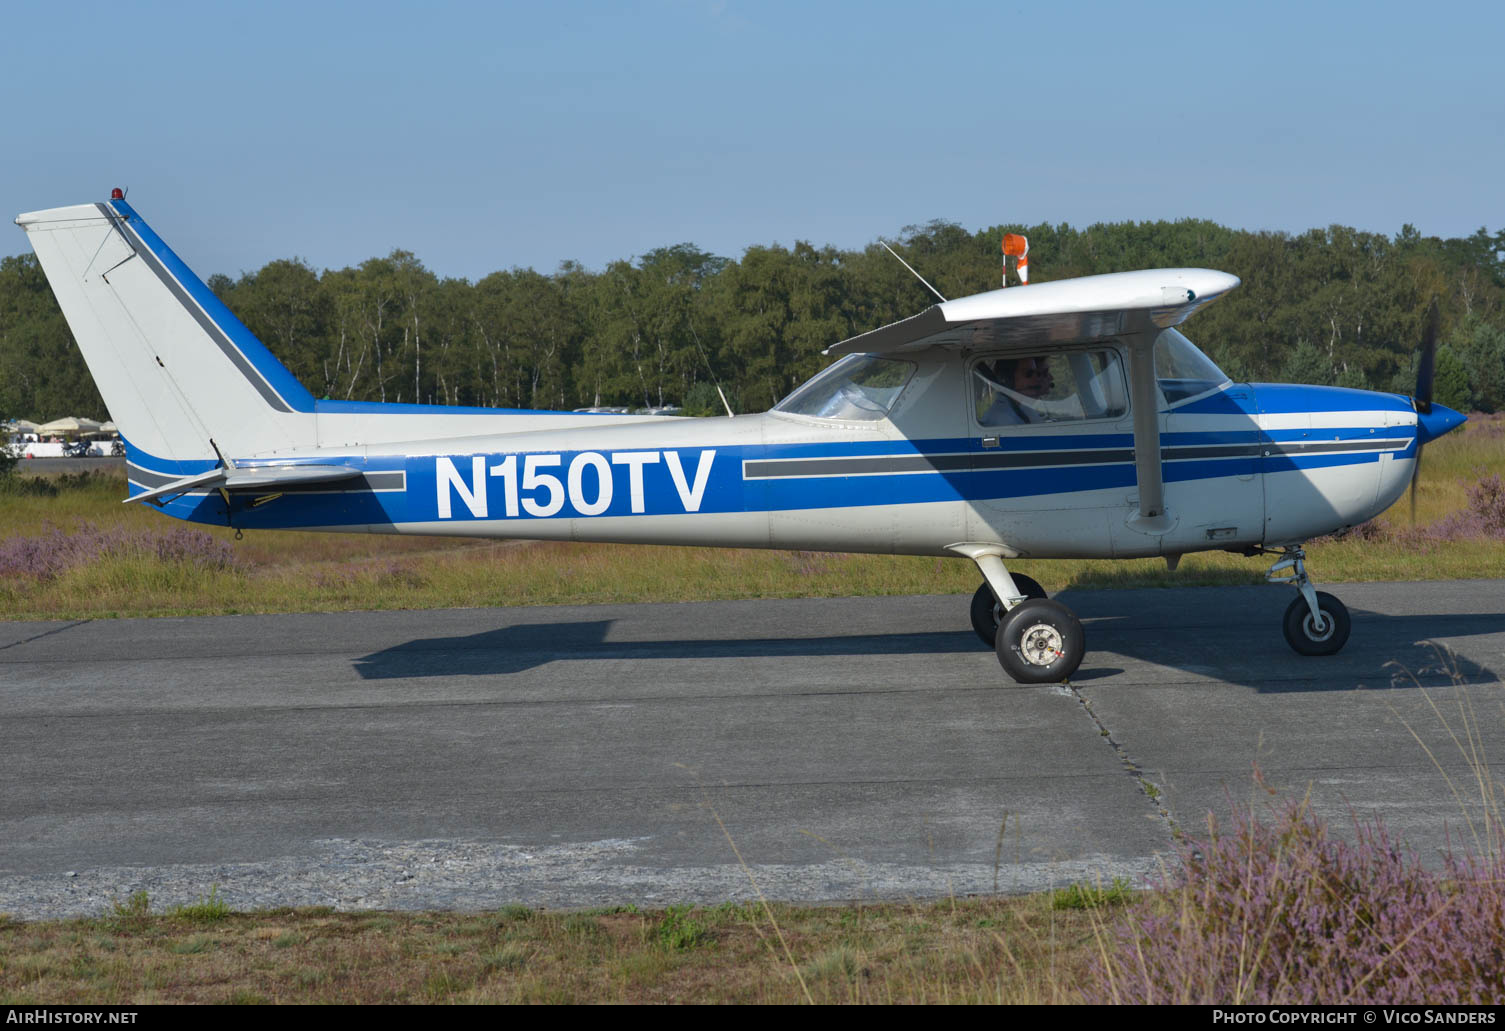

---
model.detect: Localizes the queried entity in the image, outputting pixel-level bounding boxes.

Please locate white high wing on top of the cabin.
[825,268,1239,355]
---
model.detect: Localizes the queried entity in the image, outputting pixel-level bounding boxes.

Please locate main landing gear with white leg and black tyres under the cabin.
[963,548,1087,683]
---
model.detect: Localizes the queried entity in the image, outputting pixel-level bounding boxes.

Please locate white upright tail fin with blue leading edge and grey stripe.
[15,191,316,471]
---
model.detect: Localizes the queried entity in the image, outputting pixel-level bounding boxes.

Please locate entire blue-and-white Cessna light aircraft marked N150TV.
[17,190,1463,683]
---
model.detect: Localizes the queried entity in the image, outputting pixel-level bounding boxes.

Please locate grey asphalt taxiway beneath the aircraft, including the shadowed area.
[0,581,1505,917]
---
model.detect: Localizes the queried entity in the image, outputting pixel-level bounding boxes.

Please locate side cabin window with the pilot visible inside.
[971,351,1129,426]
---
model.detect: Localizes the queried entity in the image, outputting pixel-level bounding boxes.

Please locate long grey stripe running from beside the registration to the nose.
[742,439,1410,480]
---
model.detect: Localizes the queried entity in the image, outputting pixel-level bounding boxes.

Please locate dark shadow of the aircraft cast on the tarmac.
[354,596,1505,692]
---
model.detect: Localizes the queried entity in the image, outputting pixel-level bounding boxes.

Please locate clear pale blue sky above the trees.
[0,0,1505,280]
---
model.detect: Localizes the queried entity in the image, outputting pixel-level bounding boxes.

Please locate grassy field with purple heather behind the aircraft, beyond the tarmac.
[0,415,1505,619]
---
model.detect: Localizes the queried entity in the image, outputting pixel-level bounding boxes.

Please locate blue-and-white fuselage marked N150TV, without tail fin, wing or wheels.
[131,365,1416,558]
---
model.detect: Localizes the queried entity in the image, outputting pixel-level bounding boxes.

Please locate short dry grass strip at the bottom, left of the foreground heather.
[0,896,1100,1005]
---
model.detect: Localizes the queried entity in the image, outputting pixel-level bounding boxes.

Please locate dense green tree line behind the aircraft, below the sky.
[0,220,1505,420]
